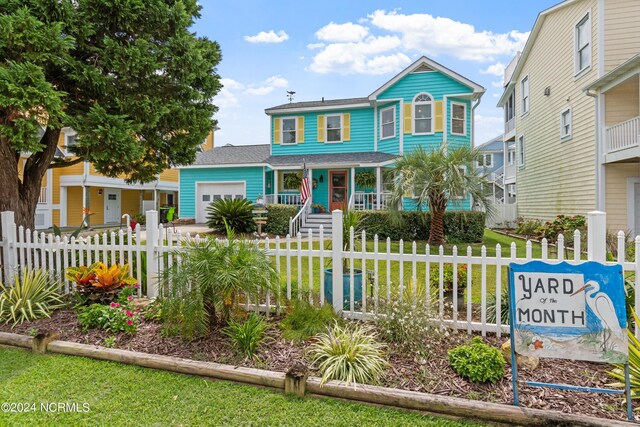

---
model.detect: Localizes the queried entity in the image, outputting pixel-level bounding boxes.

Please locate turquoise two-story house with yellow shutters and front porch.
[179,57,484,222]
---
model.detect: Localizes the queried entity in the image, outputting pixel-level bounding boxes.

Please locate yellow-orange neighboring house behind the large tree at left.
[24,128,213,229]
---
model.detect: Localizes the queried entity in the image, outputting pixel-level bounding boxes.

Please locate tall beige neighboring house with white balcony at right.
[498,0,640,234]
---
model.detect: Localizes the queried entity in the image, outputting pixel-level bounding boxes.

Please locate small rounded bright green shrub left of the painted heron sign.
[448,337,506,383]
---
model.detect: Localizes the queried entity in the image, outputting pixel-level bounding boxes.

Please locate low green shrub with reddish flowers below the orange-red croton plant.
[78,302,140,334]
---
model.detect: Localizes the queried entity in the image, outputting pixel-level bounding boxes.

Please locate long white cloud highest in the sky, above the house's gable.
[368,10,529,61]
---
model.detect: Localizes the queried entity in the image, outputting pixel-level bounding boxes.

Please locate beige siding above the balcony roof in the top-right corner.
[604,0,640,73]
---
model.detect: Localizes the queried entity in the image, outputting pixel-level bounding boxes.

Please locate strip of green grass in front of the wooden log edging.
[0,347,479,427]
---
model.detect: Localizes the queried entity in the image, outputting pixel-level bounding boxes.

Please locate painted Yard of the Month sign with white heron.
[510,261,628,363]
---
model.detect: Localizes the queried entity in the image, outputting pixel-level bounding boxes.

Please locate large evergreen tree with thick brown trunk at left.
[0,0,221,228]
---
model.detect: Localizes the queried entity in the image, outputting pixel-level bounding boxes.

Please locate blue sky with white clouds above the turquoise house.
[194,0,559,145]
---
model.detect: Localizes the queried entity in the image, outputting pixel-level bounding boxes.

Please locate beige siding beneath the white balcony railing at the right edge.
[605,163,640,233]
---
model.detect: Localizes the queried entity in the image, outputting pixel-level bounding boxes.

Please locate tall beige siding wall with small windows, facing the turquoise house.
[515,0,598,220]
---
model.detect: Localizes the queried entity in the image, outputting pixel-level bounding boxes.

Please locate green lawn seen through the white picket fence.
[270,229,556,304]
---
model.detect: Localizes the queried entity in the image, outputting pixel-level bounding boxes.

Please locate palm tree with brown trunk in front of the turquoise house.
[390,144,491,245]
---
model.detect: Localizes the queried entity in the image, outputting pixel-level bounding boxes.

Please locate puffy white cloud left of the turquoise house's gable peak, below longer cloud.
[309,36,411,74]
